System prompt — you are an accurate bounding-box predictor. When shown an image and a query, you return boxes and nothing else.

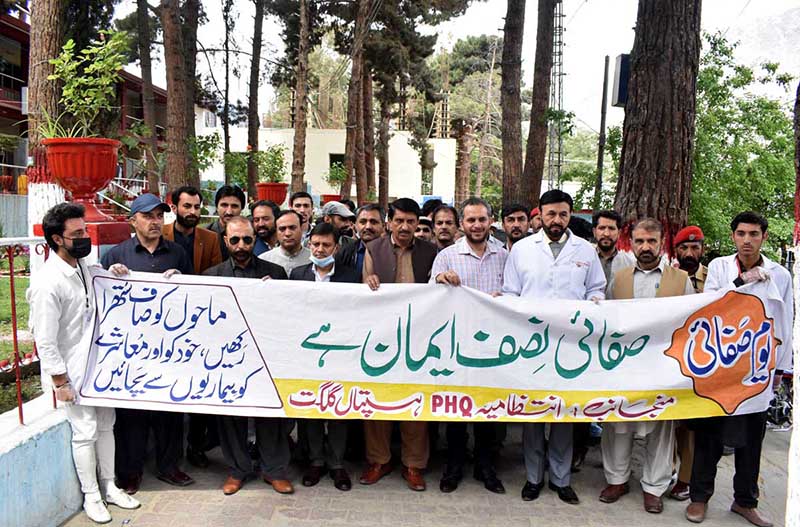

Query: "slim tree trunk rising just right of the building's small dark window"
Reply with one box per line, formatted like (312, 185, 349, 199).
(340, 0, 371, 199)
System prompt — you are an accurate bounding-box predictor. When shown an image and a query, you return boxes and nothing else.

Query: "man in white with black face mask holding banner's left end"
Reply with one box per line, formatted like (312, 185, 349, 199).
(29, 203, 139, 523)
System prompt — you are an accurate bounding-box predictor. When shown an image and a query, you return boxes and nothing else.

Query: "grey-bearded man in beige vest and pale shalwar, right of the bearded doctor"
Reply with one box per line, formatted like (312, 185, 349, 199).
(600, 218, 694, 514)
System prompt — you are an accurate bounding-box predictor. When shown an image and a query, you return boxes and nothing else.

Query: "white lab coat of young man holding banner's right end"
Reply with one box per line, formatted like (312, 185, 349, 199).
(703, 254, 794, 370)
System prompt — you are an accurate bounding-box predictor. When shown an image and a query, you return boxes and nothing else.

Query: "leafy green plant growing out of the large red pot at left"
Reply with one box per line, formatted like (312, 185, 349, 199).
(39, 31, 129, 138)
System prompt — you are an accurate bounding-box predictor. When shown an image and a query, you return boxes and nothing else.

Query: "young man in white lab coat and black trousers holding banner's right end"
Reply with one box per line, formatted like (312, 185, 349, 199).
(686, 212, 794, 527)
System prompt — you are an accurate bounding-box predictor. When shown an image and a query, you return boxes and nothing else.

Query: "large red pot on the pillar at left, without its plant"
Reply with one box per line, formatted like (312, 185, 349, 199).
(42, 137, 122, 222)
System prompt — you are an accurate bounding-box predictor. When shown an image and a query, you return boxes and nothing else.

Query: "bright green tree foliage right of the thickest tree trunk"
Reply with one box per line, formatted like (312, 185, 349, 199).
(689, 33, 795, 257)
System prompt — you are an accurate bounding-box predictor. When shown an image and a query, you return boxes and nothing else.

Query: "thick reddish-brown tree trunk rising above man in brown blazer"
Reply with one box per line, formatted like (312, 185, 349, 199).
(161, 0, 190, 187)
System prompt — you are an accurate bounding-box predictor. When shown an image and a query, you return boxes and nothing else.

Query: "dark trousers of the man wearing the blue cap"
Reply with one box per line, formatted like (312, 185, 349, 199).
(114, 408, 183, 479)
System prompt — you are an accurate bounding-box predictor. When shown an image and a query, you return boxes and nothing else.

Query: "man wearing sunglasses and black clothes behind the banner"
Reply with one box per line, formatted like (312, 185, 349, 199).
(203, 216, 294, 495)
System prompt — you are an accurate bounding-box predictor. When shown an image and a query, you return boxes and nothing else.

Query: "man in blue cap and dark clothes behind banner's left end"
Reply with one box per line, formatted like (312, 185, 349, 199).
(102, 194, 194, 494)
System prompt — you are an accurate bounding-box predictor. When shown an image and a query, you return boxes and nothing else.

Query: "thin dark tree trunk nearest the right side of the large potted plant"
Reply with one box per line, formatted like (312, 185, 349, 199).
(136, 0, 161, 194)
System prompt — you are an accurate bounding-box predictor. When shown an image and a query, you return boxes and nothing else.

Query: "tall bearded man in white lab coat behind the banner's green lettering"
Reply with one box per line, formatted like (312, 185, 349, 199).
(503, 190, 606, 504)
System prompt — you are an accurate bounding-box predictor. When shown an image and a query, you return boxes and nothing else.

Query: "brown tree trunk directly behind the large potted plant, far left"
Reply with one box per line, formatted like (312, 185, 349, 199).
(28, 0, 64, 156)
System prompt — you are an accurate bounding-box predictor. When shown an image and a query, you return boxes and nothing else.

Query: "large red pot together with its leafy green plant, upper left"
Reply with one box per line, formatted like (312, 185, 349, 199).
(39, 31, 128, 222)
